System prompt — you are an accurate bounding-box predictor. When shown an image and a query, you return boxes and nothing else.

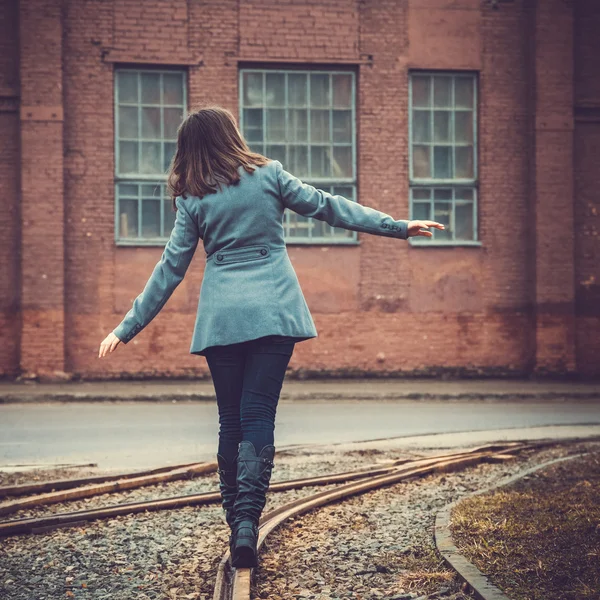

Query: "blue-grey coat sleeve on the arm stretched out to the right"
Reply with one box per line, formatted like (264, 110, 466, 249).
(274, 160, 408, 240)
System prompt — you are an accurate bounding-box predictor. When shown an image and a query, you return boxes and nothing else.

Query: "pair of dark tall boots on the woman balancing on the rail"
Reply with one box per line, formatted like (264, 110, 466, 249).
(231, 440, 275, 568)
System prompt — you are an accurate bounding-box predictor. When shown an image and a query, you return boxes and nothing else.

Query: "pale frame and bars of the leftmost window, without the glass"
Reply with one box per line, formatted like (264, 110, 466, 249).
(113, 69, 188, 247)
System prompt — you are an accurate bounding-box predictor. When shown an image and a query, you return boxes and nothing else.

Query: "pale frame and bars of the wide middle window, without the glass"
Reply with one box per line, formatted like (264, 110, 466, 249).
(238, 65, 360, 246)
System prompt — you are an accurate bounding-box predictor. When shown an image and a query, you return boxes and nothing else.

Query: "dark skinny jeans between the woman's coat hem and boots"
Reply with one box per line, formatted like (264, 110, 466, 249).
(206, 335, 296, 461)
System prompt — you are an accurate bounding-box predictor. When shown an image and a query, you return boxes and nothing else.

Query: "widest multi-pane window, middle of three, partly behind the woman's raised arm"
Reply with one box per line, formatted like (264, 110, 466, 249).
(240, 69, 357, 243)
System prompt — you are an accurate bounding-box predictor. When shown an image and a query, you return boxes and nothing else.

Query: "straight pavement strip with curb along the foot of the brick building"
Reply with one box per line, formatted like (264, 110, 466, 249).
(0, 377, 600, 404)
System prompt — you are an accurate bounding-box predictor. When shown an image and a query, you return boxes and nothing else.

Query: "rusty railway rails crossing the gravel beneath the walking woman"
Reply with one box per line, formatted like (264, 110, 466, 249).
(0, 438, 592, 600)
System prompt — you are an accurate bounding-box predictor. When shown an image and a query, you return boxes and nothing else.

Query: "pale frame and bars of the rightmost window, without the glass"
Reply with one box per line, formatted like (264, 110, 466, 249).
(408, 69, 482, 247)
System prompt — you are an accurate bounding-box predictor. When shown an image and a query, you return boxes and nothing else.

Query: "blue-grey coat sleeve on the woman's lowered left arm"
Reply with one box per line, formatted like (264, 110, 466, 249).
(113, 196, 201, 344)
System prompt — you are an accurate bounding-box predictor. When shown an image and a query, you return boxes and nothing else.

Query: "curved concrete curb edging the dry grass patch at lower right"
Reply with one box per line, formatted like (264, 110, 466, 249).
(434, 452, 589, 600)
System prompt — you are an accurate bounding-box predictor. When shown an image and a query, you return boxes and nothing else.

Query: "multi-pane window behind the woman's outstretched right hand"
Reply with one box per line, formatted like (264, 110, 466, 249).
(409, 72, 479, 245)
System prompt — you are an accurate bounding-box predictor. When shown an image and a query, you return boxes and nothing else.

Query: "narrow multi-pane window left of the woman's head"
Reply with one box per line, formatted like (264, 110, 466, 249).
(115, 68, 186, 245)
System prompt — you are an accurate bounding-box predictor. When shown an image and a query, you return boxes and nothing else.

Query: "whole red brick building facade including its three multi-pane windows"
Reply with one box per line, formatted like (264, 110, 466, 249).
(0, 0, 600, 378)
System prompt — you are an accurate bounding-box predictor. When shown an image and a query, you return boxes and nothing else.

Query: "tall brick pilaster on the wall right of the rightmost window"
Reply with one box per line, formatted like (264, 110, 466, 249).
(534, 0, 575, 372)
